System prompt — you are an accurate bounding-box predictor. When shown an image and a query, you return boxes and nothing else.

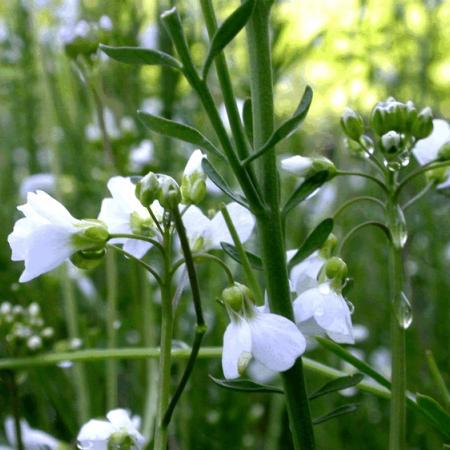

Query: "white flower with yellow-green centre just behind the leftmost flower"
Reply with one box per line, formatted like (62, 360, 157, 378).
(98, 177, 164, 258)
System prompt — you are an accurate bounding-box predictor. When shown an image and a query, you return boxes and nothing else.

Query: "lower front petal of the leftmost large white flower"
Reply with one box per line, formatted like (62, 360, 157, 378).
(19, 225, 74, 283)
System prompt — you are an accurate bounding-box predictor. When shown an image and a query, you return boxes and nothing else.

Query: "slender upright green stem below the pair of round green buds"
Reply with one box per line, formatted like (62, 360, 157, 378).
(154, 226, 173, 450)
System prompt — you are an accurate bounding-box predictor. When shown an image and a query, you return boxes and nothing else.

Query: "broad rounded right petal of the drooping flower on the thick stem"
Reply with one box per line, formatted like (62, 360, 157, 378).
(248, 312, 306, 372)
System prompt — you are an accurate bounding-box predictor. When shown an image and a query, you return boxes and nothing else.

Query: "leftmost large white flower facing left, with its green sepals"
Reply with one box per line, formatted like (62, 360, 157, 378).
(8, 191, 107, 282)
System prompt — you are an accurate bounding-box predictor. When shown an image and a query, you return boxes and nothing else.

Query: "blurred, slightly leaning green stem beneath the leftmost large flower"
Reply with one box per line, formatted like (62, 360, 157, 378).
(61, 266, 90, 424)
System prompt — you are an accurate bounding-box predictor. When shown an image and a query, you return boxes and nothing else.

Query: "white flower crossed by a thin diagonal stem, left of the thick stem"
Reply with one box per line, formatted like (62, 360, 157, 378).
(183, 202, 255, 252)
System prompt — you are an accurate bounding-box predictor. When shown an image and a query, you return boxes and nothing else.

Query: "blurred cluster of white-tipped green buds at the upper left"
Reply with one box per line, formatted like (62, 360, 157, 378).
(61, 16, 113, 58)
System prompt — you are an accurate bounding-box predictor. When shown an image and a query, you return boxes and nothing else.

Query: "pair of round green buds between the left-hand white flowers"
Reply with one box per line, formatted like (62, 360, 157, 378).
(136, 172, 181, 211)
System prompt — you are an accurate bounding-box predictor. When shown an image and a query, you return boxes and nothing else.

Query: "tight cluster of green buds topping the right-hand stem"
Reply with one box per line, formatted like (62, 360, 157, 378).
(341, 97, 433, 171)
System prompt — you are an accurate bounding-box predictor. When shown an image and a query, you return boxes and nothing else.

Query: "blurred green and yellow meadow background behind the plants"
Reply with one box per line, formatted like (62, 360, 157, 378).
(0, 0, 450, 450)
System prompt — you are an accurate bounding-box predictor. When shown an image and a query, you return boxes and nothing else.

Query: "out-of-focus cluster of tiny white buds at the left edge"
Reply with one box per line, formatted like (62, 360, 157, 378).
(0, 302, 54, 356)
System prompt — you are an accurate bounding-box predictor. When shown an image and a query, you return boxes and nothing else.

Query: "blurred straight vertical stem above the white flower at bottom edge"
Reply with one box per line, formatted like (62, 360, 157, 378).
(106, 252, 118, 411)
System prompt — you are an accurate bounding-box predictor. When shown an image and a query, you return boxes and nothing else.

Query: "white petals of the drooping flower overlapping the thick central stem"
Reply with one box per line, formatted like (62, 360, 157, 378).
(222, 305, 306, 379)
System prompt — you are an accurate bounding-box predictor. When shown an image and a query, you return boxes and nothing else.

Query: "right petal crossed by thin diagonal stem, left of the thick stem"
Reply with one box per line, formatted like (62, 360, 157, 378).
(210, 202, 255, 248)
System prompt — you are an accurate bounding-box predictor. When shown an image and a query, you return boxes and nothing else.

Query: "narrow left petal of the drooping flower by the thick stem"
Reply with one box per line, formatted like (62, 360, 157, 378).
(222, 320, 252, 380)
